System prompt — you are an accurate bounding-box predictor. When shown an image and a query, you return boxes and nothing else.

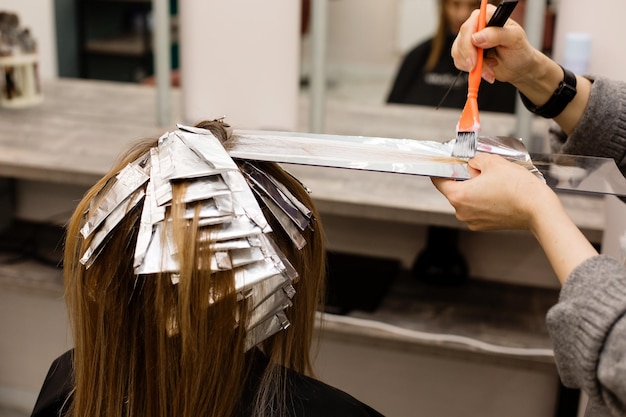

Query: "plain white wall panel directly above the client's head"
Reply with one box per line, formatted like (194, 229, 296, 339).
(179, 0, 300, 130)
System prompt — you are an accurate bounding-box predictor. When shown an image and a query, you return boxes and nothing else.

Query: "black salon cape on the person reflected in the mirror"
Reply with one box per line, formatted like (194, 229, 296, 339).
(387, 34, 517, 113)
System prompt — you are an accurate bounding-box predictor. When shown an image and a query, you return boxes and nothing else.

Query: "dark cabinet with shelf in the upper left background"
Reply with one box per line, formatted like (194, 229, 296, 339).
(77, 0, 178, 82)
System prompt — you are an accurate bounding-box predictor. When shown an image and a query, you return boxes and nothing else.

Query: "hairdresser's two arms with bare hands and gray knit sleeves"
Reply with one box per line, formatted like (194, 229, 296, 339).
(432, 7, 626, 417)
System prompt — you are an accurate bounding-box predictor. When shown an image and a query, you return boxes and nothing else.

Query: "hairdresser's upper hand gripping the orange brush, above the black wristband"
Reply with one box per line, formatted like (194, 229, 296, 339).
(452, 5, 549, 85)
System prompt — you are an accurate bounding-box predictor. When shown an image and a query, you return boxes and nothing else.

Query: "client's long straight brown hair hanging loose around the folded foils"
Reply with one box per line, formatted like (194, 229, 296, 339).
(64, 122, 325, 417)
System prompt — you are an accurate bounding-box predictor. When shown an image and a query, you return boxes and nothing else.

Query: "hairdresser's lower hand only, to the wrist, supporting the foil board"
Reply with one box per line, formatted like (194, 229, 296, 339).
(432, 153, 561, 230)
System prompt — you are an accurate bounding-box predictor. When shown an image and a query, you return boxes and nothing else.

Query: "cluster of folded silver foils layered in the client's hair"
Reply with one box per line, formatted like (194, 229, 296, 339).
(81, 126, 313, 348)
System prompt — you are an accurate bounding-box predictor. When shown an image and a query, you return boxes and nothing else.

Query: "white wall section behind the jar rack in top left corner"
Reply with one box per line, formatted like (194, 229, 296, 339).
(0, 0, 57, 79)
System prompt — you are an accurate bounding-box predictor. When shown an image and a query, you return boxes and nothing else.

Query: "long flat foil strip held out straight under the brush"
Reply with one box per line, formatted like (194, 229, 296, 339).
(224, 130, 528, 179)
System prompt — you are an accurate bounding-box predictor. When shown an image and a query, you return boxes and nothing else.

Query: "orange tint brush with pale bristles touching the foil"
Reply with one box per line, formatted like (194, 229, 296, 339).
(452, 0, 488, 159)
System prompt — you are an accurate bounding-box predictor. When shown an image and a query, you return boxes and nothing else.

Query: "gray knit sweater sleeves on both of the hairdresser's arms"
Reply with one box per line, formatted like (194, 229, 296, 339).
(547, 77, 626, 417)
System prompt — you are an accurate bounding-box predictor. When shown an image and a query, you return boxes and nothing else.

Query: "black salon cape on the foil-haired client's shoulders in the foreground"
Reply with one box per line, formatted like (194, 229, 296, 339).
(31, 351, 383, 417)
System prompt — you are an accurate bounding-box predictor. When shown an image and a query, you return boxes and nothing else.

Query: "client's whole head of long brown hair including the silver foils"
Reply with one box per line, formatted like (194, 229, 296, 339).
(64, 122, 325, 416)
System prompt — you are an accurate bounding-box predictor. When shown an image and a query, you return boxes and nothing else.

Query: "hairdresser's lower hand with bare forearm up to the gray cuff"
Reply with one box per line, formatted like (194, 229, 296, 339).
(432, 154, 598, 283)
